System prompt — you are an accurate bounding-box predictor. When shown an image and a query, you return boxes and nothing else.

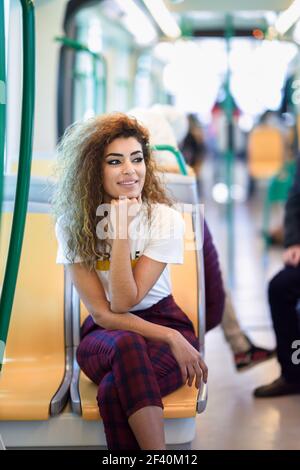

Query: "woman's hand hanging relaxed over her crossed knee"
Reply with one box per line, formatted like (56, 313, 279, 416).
(168, 330, 208, 388)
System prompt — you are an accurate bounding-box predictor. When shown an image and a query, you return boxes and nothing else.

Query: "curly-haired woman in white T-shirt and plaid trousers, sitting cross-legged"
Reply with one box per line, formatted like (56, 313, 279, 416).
(53, 113, 207, 450)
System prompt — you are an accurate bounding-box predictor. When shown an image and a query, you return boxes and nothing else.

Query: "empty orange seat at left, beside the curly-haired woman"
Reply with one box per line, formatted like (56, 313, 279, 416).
(0, 178, 72, 422)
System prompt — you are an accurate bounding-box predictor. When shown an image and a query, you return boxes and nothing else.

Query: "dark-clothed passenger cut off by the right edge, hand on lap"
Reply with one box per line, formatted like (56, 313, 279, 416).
(254, 158, 300, 398)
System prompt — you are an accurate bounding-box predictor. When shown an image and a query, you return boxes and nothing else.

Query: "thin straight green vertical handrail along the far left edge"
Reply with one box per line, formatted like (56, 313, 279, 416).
(0, 2, 6, 228)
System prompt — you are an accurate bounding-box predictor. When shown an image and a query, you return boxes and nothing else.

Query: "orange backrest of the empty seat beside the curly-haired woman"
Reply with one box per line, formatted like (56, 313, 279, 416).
(0, 202, 65, 364)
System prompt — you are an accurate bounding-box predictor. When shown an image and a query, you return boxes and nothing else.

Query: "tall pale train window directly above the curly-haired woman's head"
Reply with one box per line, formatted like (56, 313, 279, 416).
(58, 2, 144, 136)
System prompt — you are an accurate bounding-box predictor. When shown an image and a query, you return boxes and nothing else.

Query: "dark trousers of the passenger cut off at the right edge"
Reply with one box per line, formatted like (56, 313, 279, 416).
(269, 266, 300, 383)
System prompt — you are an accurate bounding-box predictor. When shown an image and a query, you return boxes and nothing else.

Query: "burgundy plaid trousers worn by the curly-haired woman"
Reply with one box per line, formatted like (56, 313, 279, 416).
(77, 295, 199, 450)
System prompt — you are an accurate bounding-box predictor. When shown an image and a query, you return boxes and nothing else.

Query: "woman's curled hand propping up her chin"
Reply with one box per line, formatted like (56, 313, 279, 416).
(111, 195, 142, 238)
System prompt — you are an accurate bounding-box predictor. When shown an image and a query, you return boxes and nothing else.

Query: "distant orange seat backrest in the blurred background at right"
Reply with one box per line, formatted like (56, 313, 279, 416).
(248, 125, 284, 179)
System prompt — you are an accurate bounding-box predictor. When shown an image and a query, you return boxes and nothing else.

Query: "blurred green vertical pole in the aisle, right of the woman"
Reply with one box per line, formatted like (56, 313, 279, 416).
(224, 14, 234, 287)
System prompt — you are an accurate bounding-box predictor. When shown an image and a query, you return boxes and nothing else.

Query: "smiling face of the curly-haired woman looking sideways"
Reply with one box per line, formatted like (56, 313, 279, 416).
(102, 137, 146, 202)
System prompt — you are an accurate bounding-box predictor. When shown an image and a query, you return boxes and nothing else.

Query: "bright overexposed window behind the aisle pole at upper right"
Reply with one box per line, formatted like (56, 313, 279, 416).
(164, 37, 297, 121)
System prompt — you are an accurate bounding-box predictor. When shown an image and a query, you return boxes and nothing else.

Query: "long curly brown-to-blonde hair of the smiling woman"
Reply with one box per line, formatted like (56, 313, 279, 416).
(52, 113, 173, 269)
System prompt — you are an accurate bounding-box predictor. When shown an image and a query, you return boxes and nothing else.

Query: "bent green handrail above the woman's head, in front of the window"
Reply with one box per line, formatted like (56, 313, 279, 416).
(55, 36, 107, 111)
